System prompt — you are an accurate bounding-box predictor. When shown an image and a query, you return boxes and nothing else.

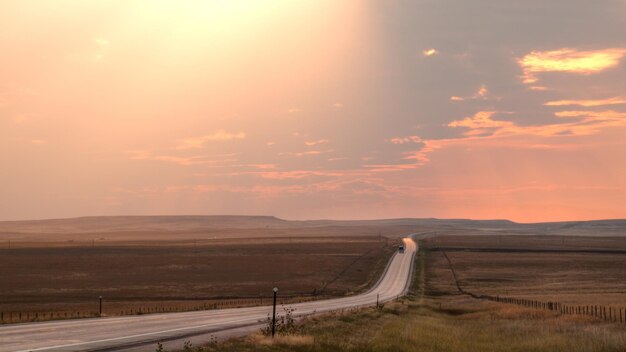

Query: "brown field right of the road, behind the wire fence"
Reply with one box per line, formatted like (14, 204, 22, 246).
(423, 235, 626, 306)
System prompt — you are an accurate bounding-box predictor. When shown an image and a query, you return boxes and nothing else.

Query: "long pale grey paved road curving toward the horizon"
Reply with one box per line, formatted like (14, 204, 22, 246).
(0, 238, 417, 352)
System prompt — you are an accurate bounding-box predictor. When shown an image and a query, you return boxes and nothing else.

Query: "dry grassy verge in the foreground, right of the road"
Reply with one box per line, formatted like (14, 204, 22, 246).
(172, 241, 626, 352)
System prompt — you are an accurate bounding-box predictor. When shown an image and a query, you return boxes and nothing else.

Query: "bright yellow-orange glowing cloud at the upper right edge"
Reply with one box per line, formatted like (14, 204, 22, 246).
(518, 48, 626, 83)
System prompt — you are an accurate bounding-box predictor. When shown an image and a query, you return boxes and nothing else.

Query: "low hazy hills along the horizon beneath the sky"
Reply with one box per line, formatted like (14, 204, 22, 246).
(0, 215, 626, 236)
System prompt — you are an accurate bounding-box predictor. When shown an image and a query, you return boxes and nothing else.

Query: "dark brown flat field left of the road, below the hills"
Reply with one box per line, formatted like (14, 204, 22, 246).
(0, 236, 395, 317)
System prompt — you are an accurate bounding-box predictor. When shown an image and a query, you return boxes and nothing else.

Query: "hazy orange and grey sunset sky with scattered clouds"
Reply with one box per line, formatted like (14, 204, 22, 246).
(0, 0, 626, 222)
